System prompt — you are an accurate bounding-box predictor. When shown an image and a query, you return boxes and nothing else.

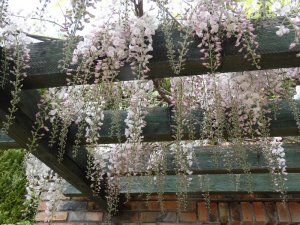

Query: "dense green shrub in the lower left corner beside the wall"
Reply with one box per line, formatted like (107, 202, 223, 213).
(0, 150, 34, 225)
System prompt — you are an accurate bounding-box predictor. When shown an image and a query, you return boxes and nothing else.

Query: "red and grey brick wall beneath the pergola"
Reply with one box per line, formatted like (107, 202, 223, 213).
(36, 195, 300, 225)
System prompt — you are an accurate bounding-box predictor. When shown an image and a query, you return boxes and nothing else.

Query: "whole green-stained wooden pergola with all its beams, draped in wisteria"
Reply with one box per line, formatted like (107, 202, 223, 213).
(0, 19, 300, 209)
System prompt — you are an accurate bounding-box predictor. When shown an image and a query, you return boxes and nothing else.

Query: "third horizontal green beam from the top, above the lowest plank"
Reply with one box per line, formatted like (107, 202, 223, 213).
(69, 144, 300, 176)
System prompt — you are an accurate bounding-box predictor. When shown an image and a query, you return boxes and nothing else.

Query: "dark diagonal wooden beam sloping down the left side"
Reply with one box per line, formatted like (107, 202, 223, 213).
(0, 89, 106, 207)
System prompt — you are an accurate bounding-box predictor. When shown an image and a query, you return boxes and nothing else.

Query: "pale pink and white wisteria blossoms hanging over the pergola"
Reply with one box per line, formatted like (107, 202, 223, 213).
(0, 0, 300, 221)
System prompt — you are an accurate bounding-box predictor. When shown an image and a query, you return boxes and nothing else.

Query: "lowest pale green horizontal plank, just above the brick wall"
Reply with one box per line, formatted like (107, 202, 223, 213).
(119, 173, 300, 194)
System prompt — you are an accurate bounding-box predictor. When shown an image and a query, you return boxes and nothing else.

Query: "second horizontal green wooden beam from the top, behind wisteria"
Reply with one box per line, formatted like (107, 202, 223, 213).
(68, 101, 300, 145)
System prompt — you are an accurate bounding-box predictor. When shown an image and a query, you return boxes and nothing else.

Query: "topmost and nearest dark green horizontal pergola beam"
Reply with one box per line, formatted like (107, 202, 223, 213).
(24, 19, 300, 89)
